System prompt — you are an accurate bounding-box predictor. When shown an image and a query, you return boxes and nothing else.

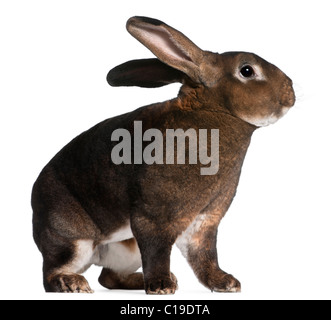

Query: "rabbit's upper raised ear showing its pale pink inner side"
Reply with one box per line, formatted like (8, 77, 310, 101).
(127, 17, 211, 83)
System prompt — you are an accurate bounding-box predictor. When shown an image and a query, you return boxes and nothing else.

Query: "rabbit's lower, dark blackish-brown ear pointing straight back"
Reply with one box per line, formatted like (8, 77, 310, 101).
(107, 59, 186, 88)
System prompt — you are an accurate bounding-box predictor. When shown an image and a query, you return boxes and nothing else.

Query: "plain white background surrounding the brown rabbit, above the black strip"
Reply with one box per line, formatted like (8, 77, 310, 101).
(0, 0, 331, 300)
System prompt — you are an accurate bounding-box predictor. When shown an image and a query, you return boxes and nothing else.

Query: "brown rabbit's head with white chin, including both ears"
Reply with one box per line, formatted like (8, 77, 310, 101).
(107, 17, 295, 127)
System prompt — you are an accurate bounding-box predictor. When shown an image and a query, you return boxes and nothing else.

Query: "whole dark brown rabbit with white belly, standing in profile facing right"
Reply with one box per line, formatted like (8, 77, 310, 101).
(31, 17, 295, 294)
